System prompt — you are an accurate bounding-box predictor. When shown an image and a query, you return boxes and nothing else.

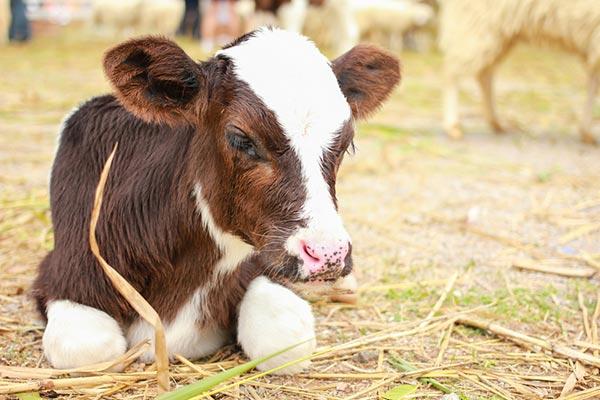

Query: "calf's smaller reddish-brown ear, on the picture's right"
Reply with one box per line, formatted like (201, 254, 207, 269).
(331, 44, 400, 119)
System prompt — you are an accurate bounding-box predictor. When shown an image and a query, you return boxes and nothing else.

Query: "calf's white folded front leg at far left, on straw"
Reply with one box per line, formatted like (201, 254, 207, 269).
(42, 300, 127, 369)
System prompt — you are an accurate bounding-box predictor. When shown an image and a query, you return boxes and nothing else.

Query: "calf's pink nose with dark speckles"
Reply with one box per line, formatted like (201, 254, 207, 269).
(300, 240, 350, 274)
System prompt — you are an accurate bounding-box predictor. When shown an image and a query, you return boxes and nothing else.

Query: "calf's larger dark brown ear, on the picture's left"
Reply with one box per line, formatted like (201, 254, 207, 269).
(104, 37, 203, 125)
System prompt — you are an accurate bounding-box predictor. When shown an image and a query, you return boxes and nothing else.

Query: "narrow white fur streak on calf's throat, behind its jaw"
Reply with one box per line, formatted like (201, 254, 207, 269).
(194, 184, 254, 274)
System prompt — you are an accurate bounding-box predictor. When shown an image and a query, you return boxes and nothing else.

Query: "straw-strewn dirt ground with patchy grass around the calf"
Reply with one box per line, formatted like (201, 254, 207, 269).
(0, 32, 600, 399)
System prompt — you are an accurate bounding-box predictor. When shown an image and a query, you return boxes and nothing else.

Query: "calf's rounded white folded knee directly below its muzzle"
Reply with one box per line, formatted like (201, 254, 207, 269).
(238, 277, 316, 374)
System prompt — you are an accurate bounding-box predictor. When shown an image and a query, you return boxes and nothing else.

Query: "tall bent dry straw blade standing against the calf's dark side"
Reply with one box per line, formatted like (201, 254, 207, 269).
(90, 143, 169, 391)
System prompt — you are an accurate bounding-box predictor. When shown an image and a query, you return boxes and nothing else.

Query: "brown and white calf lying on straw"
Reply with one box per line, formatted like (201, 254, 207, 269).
(34, 29, 399, 372)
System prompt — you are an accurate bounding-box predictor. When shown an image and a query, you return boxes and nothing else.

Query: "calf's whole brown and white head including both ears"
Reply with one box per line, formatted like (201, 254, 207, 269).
(104, 29, 399, 280)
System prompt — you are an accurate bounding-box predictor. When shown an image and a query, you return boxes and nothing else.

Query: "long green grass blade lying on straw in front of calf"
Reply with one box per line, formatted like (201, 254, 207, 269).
(158, 338, 313, 400)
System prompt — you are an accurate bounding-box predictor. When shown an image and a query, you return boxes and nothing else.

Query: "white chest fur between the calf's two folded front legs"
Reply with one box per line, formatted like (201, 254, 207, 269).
(127, 288, 227, 363)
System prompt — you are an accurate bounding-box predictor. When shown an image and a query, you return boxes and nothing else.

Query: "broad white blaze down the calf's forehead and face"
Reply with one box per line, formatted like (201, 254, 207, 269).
(218, 28, 351, 260)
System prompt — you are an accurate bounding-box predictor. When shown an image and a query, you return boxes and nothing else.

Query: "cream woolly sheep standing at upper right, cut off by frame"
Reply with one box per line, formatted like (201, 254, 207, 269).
(439, 0, 600, 143)
